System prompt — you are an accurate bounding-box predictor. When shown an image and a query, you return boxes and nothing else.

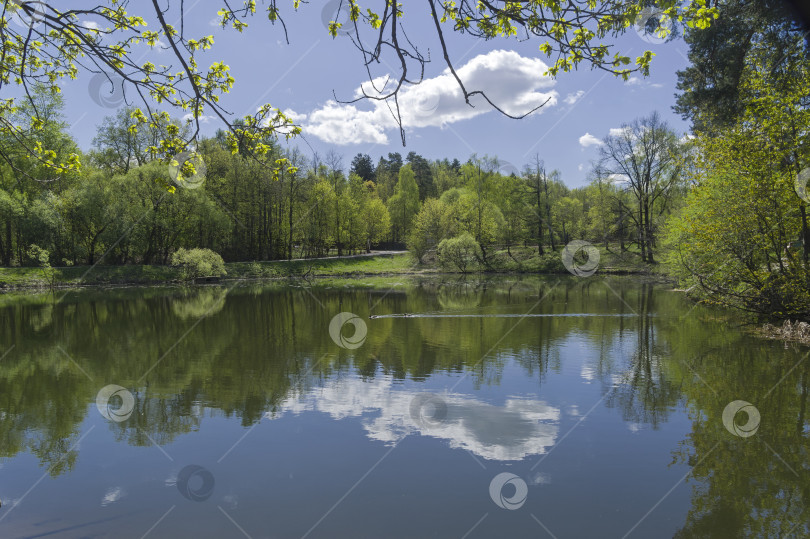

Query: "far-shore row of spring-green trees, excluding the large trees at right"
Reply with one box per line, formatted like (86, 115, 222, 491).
(0, 87, 682, 274)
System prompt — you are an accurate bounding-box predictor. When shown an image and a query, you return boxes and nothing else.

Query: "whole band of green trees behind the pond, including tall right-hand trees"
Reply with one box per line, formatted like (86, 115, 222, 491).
(0, 2, 810, 318)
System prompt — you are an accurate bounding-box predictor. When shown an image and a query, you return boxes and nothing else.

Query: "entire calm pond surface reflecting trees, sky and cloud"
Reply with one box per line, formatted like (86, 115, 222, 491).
(0, 276, 810, 538)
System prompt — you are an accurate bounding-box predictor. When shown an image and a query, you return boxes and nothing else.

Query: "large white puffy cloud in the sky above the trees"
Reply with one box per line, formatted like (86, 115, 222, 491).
(288, 50, 558, 144)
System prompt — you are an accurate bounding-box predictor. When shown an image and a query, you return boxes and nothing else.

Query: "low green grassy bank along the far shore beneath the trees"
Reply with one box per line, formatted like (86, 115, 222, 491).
(0, 247, 666, 290)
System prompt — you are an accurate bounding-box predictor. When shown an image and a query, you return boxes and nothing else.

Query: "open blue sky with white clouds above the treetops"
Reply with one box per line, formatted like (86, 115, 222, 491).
(55, 0, 688, 187)
